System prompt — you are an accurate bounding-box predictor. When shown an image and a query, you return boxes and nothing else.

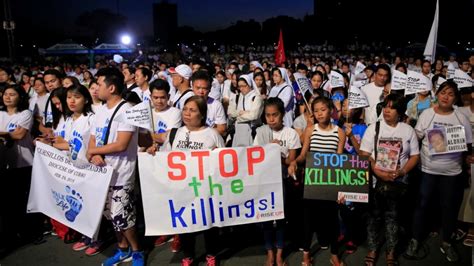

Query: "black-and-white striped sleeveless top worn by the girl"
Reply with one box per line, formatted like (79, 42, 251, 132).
(309, 124, 339, 153)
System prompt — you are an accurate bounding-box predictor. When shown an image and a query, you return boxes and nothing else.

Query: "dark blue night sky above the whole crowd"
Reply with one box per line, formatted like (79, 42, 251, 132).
(0, 0, 474, 53)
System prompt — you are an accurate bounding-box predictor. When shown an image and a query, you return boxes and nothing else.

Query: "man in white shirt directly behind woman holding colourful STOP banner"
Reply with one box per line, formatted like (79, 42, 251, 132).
(191, 70, 227, 135)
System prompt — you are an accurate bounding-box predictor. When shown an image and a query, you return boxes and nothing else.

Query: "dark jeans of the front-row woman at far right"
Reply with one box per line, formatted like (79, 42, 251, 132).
(413, 172, 463, 242)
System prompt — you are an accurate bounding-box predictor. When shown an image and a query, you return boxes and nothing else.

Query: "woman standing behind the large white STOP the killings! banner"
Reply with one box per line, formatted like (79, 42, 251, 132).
(158, 96, 224, 266)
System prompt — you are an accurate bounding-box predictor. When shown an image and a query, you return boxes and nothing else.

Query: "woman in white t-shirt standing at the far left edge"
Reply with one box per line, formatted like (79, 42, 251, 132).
(0, 85, 33, 245)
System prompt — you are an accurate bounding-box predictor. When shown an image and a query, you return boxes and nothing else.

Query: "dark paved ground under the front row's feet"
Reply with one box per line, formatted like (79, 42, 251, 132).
(0, 229, 474, 266)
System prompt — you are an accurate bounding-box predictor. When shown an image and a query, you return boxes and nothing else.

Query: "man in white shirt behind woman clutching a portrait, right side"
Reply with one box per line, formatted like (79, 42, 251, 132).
(361, 64, 392, 125)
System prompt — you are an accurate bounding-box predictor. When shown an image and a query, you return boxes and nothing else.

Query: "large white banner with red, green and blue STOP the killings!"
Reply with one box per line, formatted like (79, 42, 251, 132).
(138, 144, 284, 235)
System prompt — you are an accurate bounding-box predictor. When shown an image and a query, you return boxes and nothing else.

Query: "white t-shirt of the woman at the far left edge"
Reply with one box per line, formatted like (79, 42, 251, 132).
(0, 110, 34, 168)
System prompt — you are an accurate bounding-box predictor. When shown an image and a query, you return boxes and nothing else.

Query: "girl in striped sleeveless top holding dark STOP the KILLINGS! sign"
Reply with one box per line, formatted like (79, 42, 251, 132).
(288, 97, 346, 266)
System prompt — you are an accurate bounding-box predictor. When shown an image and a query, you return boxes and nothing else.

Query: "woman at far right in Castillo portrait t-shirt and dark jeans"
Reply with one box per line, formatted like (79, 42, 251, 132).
(405, 81, 472, 262)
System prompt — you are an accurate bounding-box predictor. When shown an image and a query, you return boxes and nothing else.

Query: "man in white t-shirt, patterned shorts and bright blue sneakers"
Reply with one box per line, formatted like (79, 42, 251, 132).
(87, 68, 145, 266)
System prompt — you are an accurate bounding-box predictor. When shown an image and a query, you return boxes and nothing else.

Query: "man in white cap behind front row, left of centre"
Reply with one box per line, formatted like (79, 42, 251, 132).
(169, 64, 194, 110)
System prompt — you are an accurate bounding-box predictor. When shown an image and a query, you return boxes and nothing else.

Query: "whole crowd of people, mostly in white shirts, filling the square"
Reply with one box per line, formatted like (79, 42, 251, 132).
(0, 52, 474, 265)
